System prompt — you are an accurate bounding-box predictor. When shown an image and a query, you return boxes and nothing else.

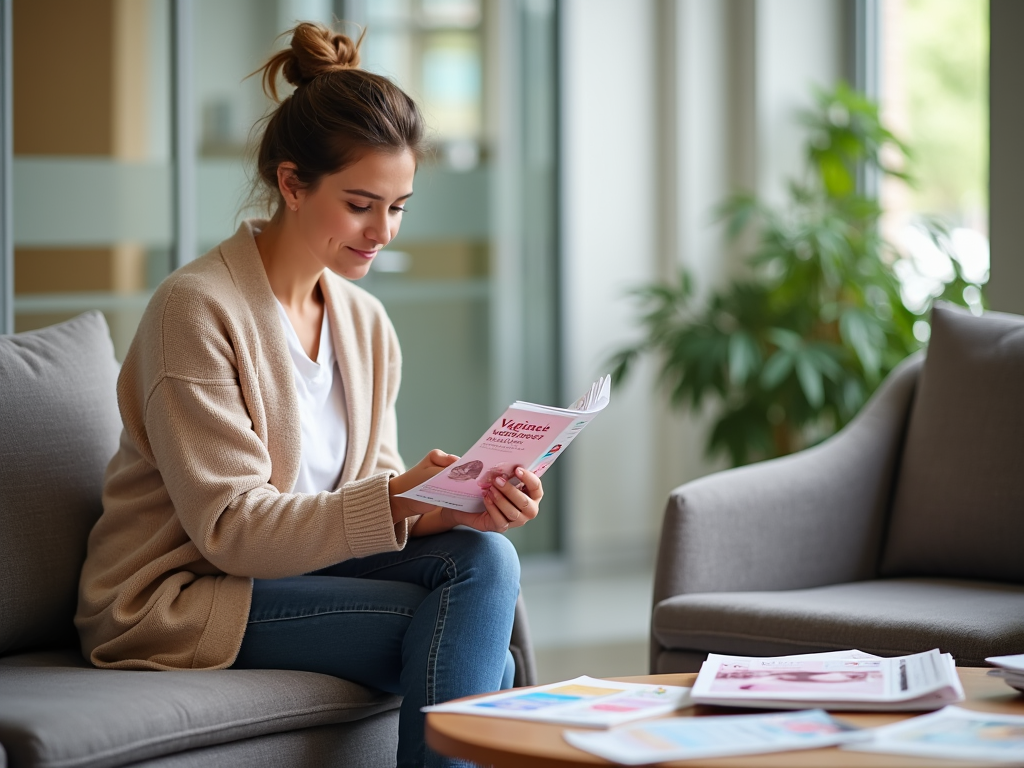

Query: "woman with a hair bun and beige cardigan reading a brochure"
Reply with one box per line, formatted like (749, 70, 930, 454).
(76, 24, 543, 765)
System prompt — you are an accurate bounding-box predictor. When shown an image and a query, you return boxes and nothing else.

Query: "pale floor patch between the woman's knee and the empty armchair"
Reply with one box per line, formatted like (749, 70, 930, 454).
(522, 563, 653, 683)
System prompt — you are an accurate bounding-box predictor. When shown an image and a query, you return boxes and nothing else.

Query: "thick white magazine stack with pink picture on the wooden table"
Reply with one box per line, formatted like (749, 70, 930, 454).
(693, 649, 964, 712)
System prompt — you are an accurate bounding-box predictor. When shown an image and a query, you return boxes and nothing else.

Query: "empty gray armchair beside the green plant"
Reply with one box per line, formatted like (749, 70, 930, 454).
(650, 305, 1024, 672)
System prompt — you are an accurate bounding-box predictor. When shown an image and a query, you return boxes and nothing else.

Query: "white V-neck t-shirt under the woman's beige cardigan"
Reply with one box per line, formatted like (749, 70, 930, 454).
(278, 301, 348, 494)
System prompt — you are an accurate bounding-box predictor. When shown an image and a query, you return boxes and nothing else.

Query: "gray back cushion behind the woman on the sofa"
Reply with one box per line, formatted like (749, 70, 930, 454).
(0, 312, 121, 654)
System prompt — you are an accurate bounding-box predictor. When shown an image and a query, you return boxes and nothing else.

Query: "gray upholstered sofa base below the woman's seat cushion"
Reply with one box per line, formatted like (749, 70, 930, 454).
(117, 710, 398, 768)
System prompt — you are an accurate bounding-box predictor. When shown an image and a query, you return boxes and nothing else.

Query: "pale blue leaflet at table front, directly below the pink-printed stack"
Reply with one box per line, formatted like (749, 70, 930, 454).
(564, 710, 863, 765)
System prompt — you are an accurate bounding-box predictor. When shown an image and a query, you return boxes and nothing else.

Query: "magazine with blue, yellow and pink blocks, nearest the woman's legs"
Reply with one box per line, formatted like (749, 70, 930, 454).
(423, 676, 690, 728)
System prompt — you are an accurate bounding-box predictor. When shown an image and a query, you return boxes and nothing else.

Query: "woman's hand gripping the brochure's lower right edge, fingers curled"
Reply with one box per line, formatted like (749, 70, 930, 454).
(407, 467, 544, 536)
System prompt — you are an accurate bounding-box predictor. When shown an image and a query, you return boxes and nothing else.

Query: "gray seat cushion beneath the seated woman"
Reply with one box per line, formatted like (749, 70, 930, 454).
(0, 651, 401, 768)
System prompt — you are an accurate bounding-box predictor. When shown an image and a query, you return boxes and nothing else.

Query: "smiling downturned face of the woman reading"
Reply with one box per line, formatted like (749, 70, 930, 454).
(295, 150, 416, 280)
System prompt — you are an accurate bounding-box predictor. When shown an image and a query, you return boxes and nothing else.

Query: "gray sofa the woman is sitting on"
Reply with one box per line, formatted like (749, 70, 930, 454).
(0, 312, 536, 768)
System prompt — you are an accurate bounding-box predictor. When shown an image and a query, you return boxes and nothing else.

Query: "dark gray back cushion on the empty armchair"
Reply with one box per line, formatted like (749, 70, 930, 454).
(882, 305, 1024, 585)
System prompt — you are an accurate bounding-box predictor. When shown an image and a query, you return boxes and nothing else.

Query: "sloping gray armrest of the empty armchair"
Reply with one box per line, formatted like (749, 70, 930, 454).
(654, 353, 924, 606)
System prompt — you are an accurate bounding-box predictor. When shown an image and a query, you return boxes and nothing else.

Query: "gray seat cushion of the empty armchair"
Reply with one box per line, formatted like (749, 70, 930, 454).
(652, 579, 1024, 666)
